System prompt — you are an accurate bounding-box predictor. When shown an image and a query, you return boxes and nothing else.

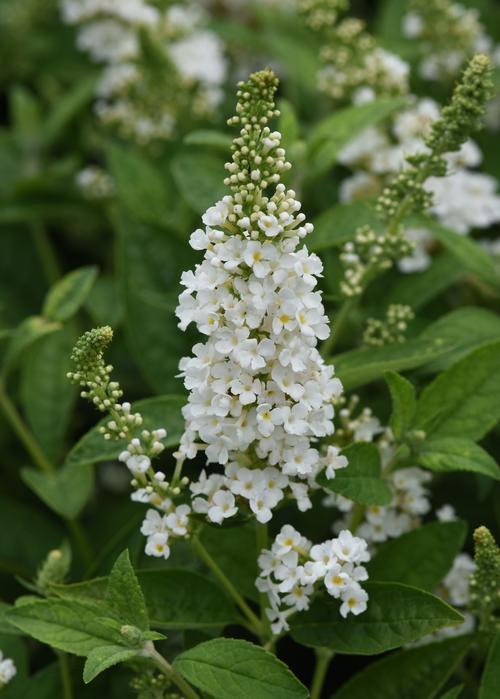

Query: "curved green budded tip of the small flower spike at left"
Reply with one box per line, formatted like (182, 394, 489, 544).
(67, 325, 142, 439)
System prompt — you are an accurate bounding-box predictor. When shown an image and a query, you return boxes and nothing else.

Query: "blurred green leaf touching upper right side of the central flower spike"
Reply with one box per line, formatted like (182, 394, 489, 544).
(307, 201, 380, 252)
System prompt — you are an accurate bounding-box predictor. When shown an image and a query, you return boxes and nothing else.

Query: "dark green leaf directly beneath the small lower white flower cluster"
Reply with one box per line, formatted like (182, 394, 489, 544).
(292, 582, 463, 655)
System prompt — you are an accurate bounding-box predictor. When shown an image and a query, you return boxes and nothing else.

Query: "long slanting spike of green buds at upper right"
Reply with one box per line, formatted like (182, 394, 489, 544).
(341, 54, 492, 297)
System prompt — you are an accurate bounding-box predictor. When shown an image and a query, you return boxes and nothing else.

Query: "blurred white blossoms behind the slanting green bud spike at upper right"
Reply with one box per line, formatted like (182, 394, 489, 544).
(339, 98, 500, 272)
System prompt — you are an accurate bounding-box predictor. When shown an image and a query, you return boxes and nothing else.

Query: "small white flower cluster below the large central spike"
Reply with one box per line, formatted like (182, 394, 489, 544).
(256, 524, 370, 635)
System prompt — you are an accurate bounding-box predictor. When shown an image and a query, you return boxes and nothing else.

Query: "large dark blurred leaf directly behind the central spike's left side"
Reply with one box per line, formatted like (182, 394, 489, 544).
(115, 212, 194, 393)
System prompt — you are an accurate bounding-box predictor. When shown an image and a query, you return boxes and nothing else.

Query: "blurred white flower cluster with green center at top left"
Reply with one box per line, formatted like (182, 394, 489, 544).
(61, 0, 227, 143)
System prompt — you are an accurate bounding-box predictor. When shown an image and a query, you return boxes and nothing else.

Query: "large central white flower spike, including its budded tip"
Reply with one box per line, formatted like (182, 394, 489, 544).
(176, 70, 342, 522)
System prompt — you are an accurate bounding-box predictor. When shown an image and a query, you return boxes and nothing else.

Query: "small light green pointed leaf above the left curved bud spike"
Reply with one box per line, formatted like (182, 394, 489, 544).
(43, 267, 97, 323)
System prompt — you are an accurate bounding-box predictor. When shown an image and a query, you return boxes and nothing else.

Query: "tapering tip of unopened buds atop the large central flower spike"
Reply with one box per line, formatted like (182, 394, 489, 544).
(224, 68, 291, 208)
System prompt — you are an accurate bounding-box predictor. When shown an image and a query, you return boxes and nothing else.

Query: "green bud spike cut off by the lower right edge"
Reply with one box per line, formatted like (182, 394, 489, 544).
(470, 527, 500, 633)
